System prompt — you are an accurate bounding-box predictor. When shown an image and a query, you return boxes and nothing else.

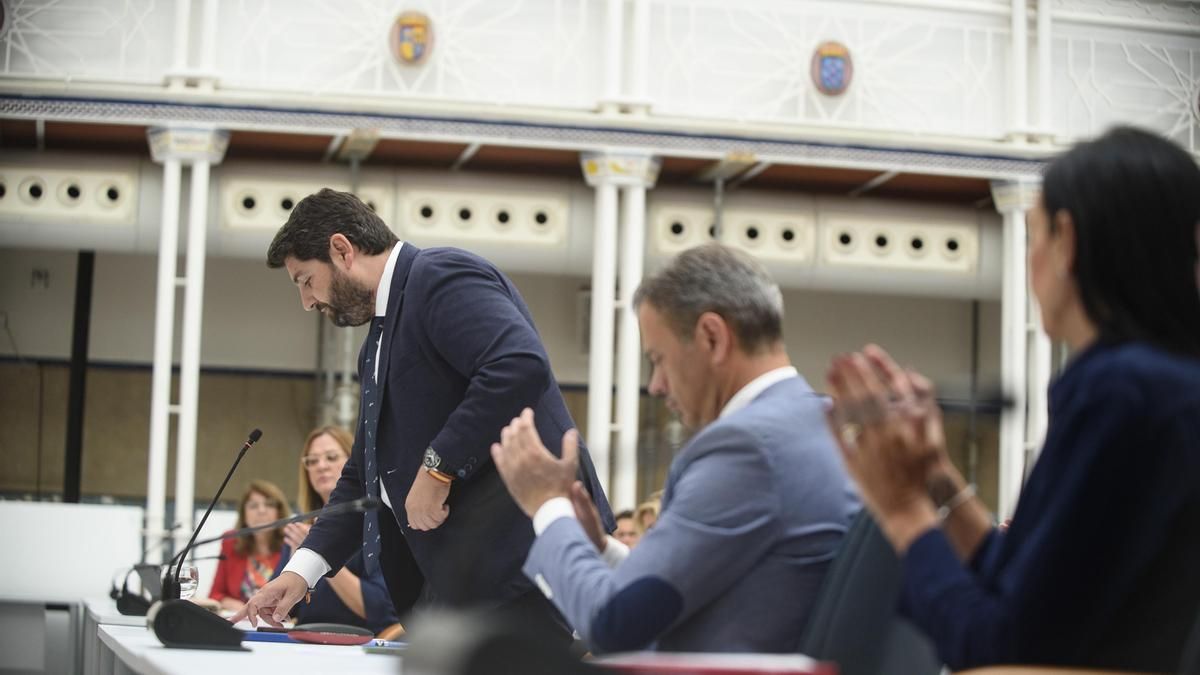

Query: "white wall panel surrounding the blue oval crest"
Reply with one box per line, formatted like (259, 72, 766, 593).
(649, 0, 1008, 138)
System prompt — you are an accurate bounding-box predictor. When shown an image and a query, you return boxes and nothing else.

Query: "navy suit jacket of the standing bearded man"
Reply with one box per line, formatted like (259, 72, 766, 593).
(305, 244, 614, 613)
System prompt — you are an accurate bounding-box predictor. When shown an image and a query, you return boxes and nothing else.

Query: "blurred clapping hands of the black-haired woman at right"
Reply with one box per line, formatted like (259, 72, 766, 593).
(827, 345, 949, 552)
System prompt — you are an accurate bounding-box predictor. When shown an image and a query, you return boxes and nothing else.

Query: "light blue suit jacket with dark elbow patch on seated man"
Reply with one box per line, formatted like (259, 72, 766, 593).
(524, 377, 859, 652)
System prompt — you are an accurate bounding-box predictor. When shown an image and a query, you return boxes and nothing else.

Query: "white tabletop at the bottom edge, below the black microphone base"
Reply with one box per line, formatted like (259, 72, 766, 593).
(98, 625, 402, 675)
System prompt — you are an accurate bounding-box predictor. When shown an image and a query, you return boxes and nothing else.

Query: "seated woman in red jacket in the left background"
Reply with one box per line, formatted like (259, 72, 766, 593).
(209, 480, 292, 611)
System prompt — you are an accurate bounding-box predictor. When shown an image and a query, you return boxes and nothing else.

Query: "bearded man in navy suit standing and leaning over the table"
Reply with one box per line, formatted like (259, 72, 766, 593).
(235, 189, 614, 638)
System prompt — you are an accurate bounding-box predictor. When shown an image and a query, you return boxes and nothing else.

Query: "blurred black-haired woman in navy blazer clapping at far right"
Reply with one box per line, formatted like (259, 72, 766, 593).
(828, 127, 1200, 671)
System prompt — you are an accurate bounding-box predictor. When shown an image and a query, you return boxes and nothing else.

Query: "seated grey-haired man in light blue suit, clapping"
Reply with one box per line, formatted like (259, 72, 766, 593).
(492, 244, 859, 652)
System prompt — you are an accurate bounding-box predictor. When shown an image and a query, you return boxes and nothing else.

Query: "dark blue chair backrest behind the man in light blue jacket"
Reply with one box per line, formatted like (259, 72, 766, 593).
(800, 510, 942, 675)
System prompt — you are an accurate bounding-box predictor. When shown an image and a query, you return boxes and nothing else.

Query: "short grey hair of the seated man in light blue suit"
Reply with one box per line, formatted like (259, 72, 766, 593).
(634, 244, 784, 354)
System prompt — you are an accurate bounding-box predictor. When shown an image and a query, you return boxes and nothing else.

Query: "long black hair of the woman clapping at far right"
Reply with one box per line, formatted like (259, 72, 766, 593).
(1042, 126, 1200, 357)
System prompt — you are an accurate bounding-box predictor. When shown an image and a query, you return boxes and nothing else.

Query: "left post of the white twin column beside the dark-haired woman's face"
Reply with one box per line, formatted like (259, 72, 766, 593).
(991, 181, 1038, 518)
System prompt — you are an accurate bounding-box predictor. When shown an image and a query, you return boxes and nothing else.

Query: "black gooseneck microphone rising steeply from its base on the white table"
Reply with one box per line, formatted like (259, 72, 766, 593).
(146, 429, 263, 650)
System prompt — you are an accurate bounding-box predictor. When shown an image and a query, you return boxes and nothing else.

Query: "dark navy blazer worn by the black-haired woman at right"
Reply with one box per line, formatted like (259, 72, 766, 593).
(902, 342, 1200, 673)
